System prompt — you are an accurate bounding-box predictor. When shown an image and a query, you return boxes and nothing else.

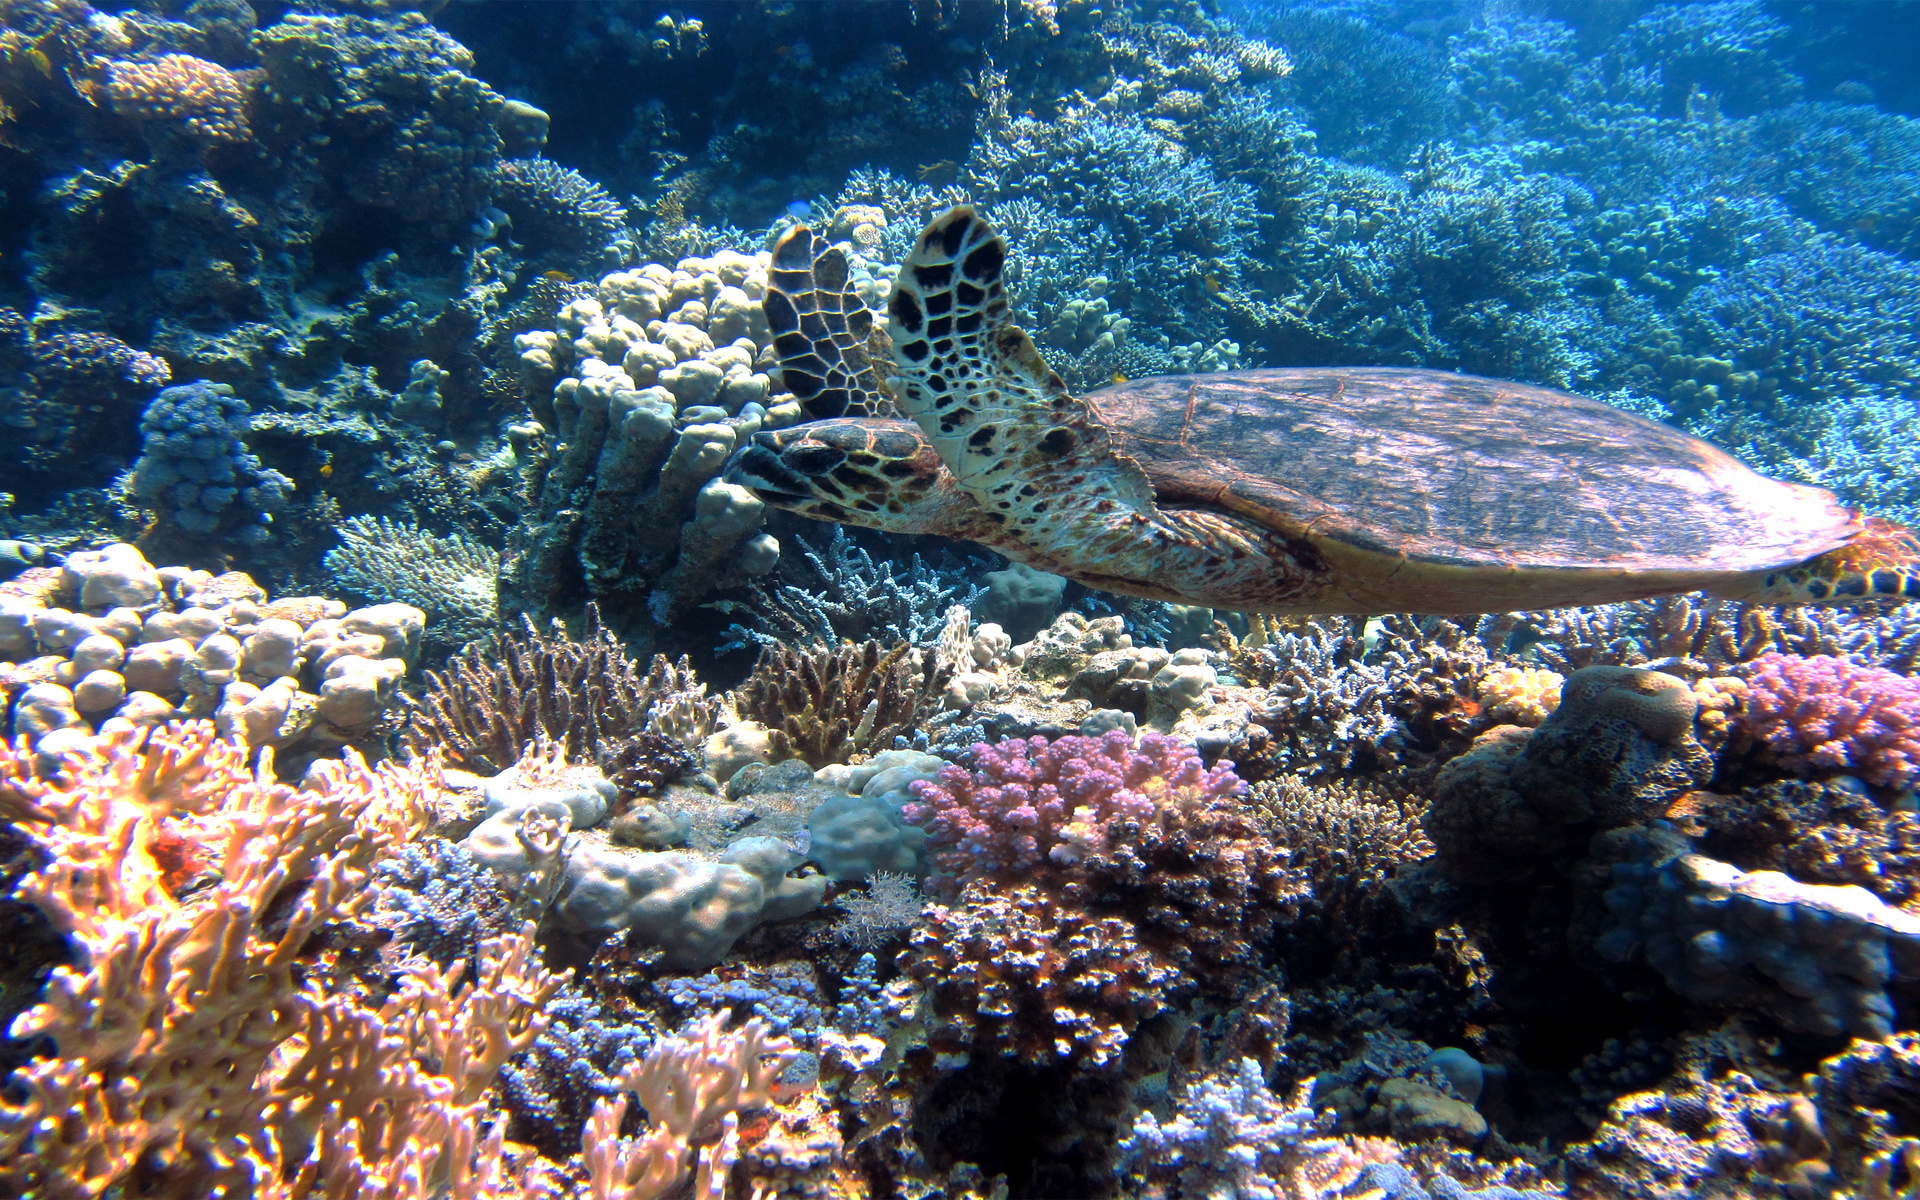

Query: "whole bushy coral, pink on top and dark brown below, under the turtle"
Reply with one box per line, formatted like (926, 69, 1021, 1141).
(906, 730, 1302, 1066)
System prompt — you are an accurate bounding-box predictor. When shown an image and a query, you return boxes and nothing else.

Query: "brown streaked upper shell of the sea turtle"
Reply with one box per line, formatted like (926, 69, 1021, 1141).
(1087, 367, 1862, 576)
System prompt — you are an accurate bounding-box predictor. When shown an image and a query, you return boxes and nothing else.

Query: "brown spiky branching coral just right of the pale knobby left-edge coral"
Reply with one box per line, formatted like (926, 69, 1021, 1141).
(407, 607, 714, 774)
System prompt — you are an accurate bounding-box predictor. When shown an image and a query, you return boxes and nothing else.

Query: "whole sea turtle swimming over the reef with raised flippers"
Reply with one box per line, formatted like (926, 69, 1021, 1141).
(728, 205, 1920, 614)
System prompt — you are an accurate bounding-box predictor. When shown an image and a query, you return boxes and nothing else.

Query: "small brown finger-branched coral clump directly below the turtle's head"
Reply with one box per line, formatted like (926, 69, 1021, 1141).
(733, 641, 952, 770)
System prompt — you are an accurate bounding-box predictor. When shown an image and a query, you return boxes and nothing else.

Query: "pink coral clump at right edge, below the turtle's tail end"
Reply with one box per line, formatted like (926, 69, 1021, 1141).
(1741, 655, 1920, 787)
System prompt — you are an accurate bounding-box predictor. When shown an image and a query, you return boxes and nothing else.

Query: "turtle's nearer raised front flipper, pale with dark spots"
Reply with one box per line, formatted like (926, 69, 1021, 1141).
(887, 205, 1158, 559)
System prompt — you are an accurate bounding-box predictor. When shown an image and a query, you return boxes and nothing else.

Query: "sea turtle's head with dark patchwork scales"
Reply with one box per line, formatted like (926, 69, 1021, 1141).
(726, 417, 950, 534)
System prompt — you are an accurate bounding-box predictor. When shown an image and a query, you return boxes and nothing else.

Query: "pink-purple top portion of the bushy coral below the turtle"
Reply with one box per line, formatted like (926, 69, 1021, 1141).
(904, 730, 1246, 881)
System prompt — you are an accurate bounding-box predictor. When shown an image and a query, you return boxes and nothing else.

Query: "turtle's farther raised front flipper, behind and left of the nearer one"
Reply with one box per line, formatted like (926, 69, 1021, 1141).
(762, 225, 900, 420)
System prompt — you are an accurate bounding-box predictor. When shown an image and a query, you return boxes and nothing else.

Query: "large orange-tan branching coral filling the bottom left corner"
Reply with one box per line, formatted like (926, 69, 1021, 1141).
(0, 722, 559, 1194)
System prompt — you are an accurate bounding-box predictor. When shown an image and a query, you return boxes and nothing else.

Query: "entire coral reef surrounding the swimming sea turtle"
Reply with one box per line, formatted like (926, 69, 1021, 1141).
(0, 0, 1920, 1200)
